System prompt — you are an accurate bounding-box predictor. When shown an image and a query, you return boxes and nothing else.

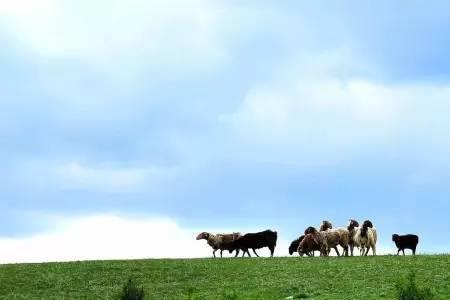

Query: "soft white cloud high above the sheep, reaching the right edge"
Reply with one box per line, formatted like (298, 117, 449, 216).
(220, 59, 450, 163)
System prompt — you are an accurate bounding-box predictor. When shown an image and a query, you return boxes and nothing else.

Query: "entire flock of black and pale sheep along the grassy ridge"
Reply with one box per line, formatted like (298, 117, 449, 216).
(197, 219, 419, 257)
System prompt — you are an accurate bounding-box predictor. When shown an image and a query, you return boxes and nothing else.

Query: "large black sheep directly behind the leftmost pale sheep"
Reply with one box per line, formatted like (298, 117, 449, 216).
(233, 230, 278, 257)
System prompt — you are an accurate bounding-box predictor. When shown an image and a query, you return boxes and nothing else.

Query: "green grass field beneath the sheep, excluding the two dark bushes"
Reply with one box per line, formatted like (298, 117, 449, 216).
(0, 255, 450, 300)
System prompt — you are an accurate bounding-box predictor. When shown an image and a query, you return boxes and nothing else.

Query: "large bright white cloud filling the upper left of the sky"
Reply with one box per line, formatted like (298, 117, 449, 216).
(0, 0, 282, 118)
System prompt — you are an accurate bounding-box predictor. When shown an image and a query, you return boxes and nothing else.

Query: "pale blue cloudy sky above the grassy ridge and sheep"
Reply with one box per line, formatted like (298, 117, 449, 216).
(0, 0, 450, 262)
